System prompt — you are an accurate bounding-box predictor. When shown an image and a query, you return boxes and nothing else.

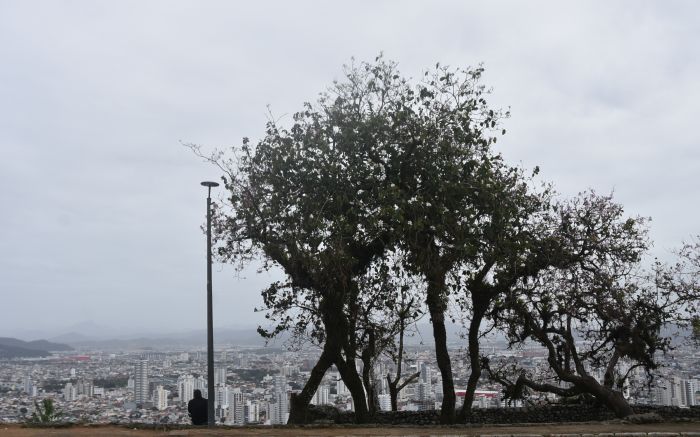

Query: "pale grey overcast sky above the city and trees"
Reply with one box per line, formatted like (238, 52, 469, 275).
(0, 0, 700, 336)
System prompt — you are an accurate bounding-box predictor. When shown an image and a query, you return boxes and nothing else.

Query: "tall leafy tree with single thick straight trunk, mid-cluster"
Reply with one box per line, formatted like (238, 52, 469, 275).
(386, 65, 521, 423)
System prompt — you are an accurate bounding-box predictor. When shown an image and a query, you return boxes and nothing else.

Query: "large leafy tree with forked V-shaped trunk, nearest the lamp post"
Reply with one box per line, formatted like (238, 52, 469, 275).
(197, 59, 424, 422)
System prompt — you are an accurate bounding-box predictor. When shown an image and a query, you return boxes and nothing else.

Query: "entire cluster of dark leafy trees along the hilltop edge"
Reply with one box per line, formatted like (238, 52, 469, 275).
(189, 56, 700, 423)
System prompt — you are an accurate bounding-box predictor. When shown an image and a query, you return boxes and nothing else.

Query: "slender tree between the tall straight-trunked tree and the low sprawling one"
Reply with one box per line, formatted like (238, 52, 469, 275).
(454, 163, 564, 422)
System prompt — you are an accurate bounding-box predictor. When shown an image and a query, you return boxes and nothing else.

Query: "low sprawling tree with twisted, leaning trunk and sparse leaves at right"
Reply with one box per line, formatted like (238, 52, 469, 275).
(486, 194, 678, 417)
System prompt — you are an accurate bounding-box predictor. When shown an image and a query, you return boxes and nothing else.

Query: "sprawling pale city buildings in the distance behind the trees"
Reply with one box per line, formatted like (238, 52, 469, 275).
(0, 338, 700, 425)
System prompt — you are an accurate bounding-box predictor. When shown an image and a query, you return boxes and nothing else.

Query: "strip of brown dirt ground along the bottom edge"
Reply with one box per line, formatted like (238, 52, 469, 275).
(0, 422, 700, 437)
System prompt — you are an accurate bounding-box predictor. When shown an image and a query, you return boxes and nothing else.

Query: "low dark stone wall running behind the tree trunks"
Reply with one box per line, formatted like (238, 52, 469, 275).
(310, 405, 700, 425)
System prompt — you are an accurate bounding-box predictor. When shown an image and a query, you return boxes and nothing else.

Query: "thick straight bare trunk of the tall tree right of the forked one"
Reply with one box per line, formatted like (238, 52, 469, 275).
(426, 274, 455, 424)
